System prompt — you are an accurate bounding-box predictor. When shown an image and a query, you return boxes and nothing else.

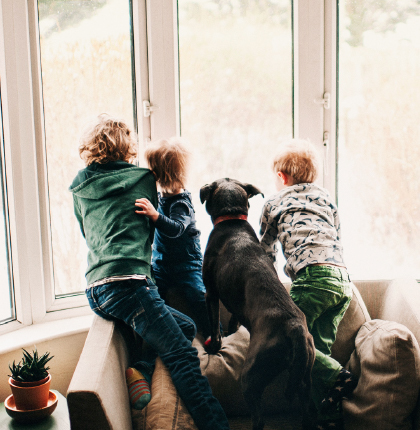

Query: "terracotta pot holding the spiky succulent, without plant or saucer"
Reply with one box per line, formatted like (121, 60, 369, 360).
(9, 374, 51, 411)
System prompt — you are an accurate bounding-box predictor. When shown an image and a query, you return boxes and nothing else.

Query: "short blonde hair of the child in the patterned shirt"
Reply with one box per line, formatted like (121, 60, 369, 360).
(272, 139, 320, 184)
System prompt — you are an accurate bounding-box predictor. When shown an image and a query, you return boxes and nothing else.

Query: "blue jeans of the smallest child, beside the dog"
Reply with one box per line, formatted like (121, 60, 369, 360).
(153, 268, 211, 339)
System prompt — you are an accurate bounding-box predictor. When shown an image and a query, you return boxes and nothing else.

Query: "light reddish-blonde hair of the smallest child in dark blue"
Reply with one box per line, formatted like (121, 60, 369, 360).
(144, 137, 190, 192)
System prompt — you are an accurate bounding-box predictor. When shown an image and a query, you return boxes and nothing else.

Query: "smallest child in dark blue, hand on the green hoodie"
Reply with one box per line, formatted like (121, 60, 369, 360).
(136, 138, 210, 338)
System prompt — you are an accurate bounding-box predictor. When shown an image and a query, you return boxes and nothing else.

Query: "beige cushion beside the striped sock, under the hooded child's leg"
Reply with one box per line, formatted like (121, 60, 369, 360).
(132, 357, 197, 430)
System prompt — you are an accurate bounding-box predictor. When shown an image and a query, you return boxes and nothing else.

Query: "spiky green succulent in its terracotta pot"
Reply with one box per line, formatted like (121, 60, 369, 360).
(9, 348, 53, 410)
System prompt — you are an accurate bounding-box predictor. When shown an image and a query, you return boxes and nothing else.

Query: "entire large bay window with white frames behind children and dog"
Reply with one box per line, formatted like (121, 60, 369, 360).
(0, 0, 420, 332)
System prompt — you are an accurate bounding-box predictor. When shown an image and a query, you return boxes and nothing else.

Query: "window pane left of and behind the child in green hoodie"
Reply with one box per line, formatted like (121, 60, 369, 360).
(38, 0, 134, 295)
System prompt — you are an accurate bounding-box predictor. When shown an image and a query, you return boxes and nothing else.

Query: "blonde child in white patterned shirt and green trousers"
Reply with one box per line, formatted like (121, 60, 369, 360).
(260, 139, 357, 430)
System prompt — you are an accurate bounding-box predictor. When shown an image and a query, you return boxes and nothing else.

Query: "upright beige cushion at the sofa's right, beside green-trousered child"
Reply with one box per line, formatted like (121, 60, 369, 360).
(343, 320, 420, 430)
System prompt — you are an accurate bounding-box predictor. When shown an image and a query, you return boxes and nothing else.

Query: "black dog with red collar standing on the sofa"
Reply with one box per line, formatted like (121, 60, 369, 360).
(200, 178, 315, 430)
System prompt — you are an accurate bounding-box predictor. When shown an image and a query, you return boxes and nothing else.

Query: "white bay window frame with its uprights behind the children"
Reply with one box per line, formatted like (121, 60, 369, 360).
(0, 0, 337, 333)
